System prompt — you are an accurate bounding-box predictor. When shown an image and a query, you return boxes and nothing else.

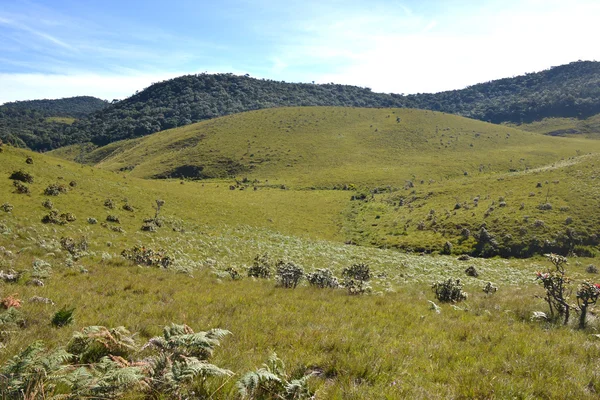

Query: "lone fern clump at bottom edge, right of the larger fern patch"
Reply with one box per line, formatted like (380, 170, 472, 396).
(237, 353, 314, 400)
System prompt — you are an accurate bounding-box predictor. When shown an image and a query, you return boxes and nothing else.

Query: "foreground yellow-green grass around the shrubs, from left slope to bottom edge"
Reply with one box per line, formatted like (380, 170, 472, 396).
(0, 144, 600, 399)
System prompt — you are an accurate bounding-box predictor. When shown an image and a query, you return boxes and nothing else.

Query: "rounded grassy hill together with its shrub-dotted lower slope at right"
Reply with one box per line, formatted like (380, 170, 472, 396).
(69, 107, 600, 257)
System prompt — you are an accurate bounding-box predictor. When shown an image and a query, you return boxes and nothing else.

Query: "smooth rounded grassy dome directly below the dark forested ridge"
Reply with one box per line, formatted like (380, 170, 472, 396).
(85, 107, 600, 187)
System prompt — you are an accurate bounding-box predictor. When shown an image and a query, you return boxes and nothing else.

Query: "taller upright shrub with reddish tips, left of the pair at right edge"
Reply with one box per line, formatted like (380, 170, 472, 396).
(536, 254, 571, 325)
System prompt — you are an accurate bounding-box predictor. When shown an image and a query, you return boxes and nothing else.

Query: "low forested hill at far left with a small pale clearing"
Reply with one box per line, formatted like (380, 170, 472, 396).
(0, 96, 108, 150)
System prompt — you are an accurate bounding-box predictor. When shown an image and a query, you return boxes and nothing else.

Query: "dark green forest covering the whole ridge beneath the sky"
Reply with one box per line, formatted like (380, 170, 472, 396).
(0, 61, 600, 150)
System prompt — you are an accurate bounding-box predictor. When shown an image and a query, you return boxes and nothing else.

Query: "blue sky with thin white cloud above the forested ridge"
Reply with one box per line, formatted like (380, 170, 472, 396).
(0, 0, 600, 104)
